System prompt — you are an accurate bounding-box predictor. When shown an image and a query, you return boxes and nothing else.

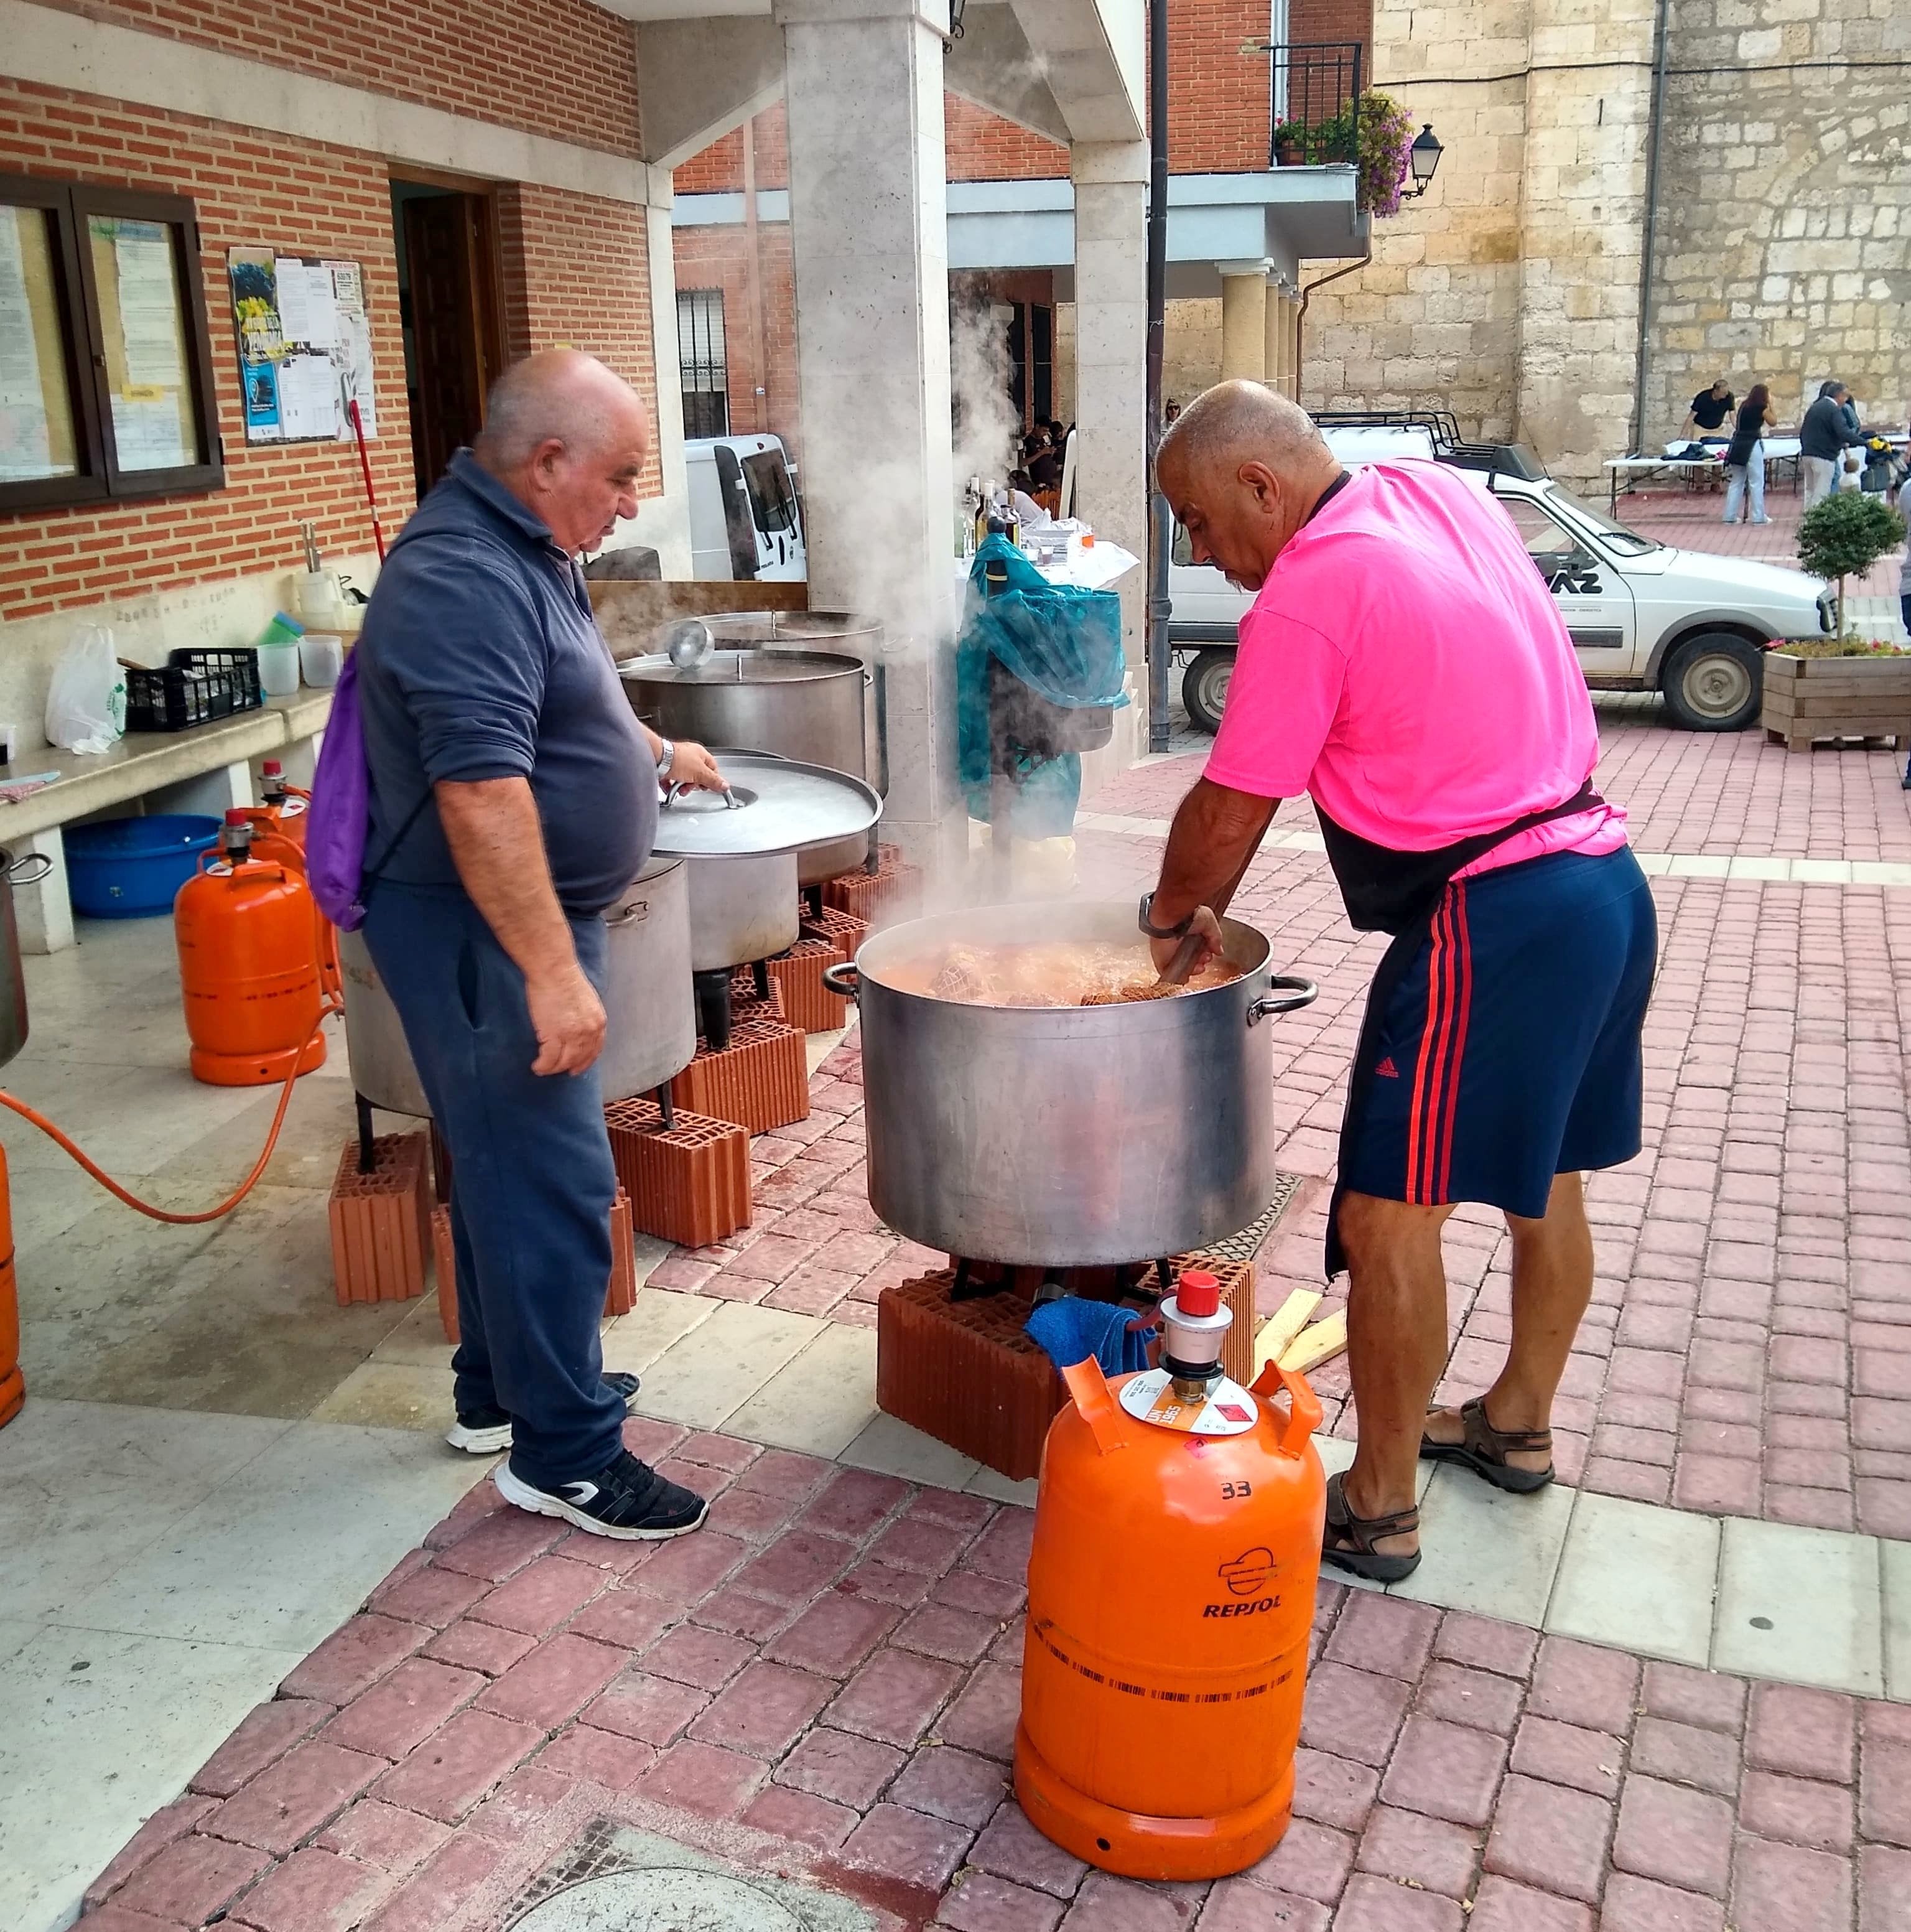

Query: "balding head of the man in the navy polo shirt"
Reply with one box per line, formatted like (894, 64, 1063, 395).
(472, 350, 649, 553)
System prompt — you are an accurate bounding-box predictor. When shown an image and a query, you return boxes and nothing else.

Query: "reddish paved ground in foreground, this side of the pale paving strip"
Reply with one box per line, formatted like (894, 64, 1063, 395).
(85, 1422, 1911, 1932)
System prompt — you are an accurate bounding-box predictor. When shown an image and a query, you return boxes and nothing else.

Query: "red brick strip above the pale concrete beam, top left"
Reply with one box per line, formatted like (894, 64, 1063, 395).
(42, 0, 638, 154)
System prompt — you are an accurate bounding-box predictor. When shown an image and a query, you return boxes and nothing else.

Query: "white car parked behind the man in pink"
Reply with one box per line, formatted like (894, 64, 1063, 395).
(1167, 416, 1838, 732)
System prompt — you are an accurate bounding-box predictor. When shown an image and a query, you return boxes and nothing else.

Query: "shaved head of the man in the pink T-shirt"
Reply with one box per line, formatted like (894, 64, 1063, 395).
(1155, 383, 1341, 589)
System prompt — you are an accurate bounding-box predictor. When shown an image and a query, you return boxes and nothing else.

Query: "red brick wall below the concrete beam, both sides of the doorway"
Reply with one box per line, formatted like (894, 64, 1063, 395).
(0, 79, 659, 620)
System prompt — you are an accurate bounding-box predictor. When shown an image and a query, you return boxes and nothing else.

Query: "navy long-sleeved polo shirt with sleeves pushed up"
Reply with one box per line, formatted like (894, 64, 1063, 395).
(351, 450, 657, 914)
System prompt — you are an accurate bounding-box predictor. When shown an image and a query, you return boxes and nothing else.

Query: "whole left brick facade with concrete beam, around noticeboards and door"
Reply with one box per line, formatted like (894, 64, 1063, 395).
(0, 0, 674, 745)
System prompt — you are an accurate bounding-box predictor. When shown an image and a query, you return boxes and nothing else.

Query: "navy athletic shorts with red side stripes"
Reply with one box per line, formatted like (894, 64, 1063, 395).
(1339, 848, 1658, 1219)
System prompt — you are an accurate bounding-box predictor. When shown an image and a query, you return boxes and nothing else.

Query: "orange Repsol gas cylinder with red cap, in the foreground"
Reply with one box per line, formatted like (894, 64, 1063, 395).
(1015, 1271, 1327, 1880)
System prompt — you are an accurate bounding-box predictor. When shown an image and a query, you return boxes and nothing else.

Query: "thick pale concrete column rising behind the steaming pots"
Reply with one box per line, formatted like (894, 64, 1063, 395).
(775, 0, 968, 866)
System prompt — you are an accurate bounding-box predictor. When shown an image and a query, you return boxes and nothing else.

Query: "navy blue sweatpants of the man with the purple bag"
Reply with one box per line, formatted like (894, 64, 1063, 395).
(363, 883, 624, 1490)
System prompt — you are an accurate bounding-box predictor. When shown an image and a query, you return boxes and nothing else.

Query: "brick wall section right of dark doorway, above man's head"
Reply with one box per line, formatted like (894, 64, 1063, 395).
(498, 182, 663, 497)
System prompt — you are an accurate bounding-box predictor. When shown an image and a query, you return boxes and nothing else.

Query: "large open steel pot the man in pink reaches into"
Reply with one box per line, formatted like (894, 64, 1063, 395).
(833, 902, 1316, 1266)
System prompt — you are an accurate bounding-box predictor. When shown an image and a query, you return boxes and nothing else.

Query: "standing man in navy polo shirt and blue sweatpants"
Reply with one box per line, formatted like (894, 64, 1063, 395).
(356, 350, 723, 1540)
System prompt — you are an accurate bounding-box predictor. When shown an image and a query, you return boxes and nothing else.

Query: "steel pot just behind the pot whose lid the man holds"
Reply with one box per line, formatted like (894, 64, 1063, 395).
(618, 645, 873, 885)
